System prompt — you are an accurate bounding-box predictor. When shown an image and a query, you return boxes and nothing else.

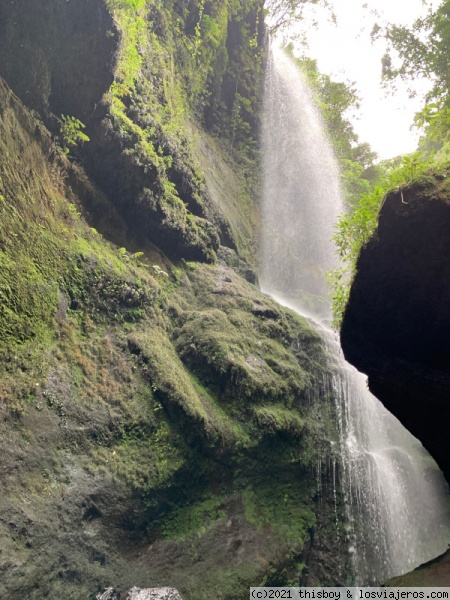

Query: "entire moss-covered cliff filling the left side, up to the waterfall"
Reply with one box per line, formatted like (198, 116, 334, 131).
(0, 0, 347, 600)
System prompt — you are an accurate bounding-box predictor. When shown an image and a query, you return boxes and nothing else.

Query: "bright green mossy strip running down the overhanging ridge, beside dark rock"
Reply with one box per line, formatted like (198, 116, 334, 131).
(100, 2, 223, 261)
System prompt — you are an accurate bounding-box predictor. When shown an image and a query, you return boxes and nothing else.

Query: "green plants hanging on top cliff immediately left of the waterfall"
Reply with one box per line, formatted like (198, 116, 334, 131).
(185, 0, 263, 160)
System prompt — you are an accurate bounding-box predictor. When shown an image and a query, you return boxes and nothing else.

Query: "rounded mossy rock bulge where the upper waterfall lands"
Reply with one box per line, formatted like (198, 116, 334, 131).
(175, 266, 326, 407)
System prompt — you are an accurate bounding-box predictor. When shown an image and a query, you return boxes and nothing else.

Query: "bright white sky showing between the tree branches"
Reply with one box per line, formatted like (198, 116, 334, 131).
(290, 0, 434, 159)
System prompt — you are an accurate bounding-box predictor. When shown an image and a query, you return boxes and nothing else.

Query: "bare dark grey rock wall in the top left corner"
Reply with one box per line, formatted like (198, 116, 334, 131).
(0, 0, 118, 123)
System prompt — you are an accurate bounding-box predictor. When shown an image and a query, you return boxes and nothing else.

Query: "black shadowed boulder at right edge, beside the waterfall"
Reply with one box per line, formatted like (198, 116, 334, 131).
(341, 178, 450, 481)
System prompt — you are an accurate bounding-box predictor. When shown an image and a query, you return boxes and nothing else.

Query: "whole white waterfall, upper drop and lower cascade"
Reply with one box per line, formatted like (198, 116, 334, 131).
(260, 47, 450, 585)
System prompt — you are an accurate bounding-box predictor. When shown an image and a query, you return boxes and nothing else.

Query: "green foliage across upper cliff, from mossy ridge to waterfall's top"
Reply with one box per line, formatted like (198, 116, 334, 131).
(98, 0, 262, 261)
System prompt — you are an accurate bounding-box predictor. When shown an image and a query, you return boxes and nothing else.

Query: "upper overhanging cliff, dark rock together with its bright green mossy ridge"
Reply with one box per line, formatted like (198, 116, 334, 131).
(0, 0, 264, 262)
